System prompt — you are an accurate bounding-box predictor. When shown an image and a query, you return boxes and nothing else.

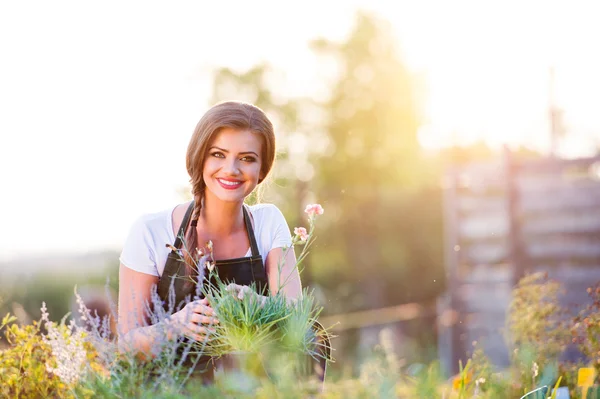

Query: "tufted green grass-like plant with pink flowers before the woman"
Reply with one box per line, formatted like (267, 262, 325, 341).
(172, 204, 333, 381)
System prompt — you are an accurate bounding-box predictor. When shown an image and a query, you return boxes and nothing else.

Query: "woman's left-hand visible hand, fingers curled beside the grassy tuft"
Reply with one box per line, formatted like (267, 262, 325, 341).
(167, 298, 219, 342)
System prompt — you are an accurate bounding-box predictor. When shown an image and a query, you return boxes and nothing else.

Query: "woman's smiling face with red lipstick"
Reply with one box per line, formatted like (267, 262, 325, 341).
(202, 128, 262, 202)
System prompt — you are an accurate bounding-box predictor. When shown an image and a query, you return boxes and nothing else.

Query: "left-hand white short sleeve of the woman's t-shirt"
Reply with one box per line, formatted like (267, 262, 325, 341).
(119, 217, 159, 276)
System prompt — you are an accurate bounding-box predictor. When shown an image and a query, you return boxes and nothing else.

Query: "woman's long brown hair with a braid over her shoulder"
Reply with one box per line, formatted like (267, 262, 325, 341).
(185, 101, 275, 273)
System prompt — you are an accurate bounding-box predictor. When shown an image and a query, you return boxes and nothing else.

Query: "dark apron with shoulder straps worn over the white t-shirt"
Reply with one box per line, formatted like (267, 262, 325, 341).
(158, 201, 269, 382)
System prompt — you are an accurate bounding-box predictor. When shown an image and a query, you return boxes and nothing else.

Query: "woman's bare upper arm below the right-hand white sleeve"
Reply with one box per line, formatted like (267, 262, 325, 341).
(265, 247, 302, 300)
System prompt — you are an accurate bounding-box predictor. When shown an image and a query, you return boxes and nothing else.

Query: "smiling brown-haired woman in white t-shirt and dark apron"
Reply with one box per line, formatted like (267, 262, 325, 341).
(118, 102, 302, 368)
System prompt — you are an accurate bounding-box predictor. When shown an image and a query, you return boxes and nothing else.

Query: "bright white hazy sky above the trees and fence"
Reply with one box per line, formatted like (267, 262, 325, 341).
(0, 0, 600, 261)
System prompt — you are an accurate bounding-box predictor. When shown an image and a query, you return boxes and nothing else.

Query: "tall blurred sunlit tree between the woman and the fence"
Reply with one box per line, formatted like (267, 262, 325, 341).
(312, 13, 444, 310)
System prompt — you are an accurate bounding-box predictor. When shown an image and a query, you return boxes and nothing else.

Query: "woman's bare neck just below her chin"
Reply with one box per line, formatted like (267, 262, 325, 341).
(198, 196, 244, 236)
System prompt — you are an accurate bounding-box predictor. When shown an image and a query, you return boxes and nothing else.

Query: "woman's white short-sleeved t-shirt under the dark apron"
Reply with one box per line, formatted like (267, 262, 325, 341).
(119, 204, 292, 276)
